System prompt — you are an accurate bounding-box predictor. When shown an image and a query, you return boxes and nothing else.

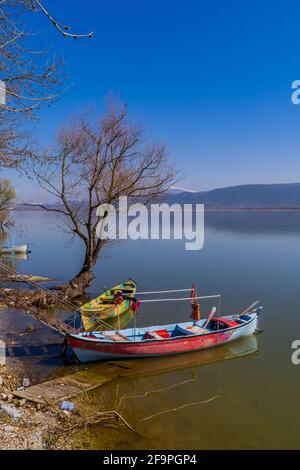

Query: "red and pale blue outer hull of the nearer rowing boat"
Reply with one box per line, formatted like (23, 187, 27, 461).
(68, 314, 258, 362)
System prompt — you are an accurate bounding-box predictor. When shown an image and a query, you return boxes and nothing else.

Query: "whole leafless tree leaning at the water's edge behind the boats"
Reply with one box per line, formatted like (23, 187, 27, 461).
(26, 104, 176, 294)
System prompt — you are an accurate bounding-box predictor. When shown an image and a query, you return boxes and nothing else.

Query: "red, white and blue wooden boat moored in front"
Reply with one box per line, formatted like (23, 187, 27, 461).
(67, 302, 262, 362)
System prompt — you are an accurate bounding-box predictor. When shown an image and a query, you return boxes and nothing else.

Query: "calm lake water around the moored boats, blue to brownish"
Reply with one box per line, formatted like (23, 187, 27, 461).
(0, 211, 300, 449)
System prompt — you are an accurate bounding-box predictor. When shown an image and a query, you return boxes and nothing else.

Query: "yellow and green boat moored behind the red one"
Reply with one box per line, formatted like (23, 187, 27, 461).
(80, 279, 137, 331)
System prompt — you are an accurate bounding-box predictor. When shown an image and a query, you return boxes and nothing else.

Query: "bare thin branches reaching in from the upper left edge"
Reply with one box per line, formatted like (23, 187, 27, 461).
(0, 0, 92, 166)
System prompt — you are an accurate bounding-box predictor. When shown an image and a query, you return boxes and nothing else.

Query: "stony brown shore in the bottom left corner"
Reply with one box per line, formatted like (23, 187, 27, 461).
(0, 365, 129, 450)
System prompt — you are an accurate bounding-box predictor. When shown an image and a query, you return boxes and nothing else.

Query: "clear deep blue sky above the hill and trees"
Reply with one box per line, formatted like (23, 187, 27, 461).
(7, 0, 300, 199)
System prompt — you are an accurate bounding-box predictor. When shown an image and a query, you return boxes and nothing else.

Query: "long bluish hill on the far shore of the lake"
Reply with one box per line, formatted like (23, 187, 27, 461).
(167, 183, 300, 209)
